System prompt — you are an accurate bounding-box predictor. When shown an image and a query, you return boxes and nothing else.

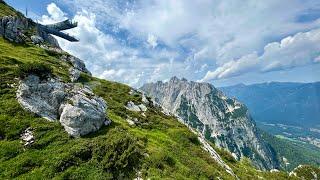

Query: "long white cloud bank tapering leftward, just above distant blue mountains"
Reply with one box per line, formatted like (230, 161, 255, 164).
(202, 29, 320, 81)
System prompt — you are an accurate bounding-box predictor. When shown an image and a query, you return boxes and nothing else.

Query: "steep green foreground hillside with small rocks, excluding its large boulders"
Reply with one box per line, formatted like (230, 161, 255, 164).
(0, 1, 320, 179)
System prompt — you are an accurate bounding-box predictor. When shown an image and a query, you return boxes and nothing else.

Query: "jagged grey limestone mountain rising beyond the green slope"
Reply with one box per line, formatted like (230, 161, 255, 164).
(141, 77, 278, 169)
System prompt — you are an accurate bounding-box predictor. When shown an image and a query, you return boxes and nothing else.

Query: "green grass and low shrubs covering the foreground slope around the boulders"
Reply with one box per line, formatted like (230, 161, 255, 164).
(0, 38, 230, 179)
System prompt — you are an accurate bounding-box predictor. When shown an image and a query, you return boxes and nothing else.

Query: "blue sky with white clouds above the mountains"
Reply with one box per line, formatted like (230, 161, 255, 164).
(6, 0, 320, 87)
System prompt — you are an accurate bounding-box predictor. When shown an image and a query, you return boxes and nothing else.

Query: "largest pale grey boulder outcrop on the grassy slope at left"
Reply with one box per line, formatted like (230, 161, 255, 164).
(17, 75, 107, 136)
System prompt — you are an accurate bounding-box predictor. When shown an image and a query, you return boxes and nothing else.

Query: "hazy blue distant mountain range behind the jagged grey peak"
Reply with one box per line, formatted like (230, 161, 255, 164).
(220, 82, 320, 128)
